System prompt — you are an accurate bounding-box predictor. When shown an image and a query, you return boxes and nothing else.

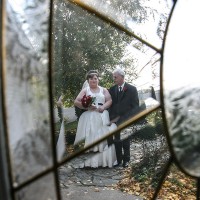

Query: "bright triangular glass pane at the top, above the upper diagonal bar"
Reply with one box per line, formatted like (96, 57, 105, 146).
(71, 0, 172, 48)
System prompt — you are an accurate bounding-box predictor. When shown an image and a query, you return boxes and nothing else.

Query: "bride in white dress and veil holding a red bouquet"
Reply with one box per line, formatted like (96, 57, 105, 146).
(74, 70, 117, 168)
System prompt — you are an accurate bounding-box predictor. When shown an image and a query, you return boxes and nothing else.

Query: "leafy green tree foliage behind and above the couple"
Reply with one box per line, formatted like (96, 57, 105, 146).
(53, 0, 162, 106)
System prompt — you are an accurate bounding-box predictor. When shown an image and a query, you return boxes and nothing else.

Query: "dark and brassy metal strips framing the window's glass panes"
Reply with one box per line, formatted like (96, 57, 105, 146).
(0, 0, 200, 200)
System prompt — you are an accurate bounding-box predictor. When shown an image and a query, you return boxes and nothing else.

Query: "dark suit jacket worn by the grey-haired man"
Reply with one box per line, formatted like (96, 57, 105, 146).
(109, 83, 139, 125)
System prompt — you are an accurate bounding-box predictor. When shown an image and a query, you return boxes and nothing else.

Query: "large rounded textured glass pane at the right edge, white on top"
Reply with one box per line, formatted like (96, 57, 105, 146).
(164, 0, 200, 177)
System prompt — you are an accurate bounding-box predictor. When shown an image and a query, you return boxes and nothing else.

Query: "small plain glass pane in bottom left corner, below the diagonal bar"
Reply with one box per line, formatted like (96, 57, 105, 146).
(15, 174, 57, 200)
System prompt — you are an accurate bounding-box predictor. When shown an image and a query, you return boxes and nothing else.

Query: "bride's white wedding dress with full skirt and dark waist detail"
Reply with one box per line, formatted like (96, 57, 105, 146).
(74, 86, 117, 168)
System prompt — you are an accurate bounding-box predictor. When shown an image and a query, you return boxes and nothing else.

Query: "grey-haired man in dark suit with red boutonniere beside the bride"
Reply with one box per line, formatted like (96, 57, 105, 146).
(109, 68, 139, 167)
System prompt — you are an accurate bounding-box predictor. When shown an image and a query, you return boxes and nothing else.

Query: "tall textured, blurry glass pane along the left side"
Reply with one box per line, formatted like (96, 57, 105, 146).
(4, 1, 52, 183)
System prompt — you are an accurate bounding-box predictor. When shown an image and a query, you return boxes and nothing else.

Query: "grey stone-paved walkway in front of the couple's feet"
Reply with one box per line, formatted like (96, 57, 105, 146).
(59, 145, 142, 200)
